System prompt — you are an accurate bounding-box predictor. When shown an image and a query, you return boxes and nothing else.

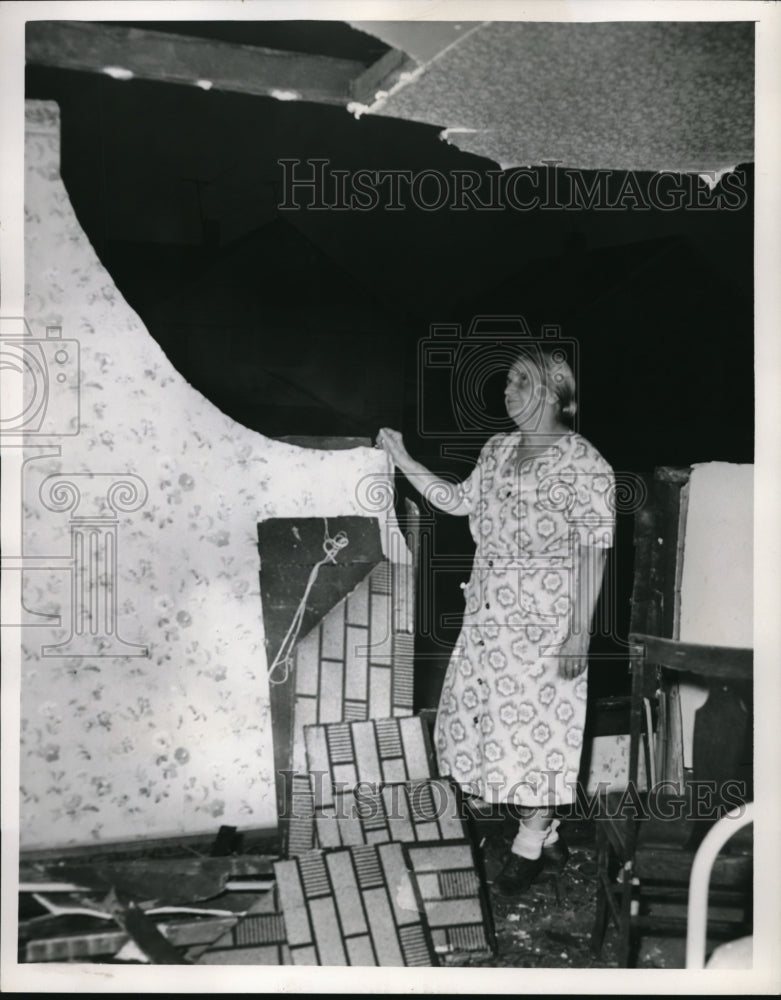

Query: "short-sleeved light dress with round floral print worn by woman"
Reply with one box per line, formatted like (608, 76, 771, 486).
(436, 432, 615, 807)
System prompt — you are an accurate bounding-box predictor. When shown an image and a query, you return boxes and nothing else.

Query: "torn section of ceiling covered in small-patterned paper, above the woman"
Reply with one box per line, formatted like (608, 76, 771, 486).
(350, 21, 754, 174)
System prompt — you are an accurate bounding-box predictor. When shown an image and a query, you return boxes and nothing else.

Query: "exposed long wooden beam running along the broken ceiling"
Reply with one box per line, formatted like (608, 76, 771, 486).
(26, 21, 408, 105)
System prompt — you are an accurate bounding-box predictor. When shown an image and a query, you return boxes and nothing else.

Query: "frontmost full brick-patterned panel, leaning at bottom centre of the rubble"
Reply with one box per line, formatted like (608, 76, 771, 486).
(274, 844, 437, 966)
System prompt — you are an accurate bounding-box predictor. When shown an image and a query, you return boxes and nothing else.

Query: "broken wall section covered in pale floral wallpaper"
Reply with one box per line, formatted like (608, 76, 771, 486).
(18, 101, 406, 848)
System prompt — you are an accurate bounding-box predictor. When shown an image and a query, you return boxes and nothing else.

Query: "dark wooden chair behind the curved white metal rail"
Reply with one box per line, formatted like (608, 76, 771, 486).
(592, 634, 753, 967)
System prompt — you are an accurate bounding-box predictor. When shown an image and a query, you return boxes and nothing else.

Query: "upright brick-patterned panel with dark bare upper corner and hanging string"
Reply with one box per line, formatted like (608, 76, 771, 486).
(259, 518, 414, 854)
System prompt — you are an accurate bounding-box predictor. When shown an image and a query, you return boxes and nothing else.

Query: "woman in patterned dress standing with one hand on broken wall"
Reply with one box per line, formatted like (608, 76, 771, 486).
(377, 344, 614, 898)
